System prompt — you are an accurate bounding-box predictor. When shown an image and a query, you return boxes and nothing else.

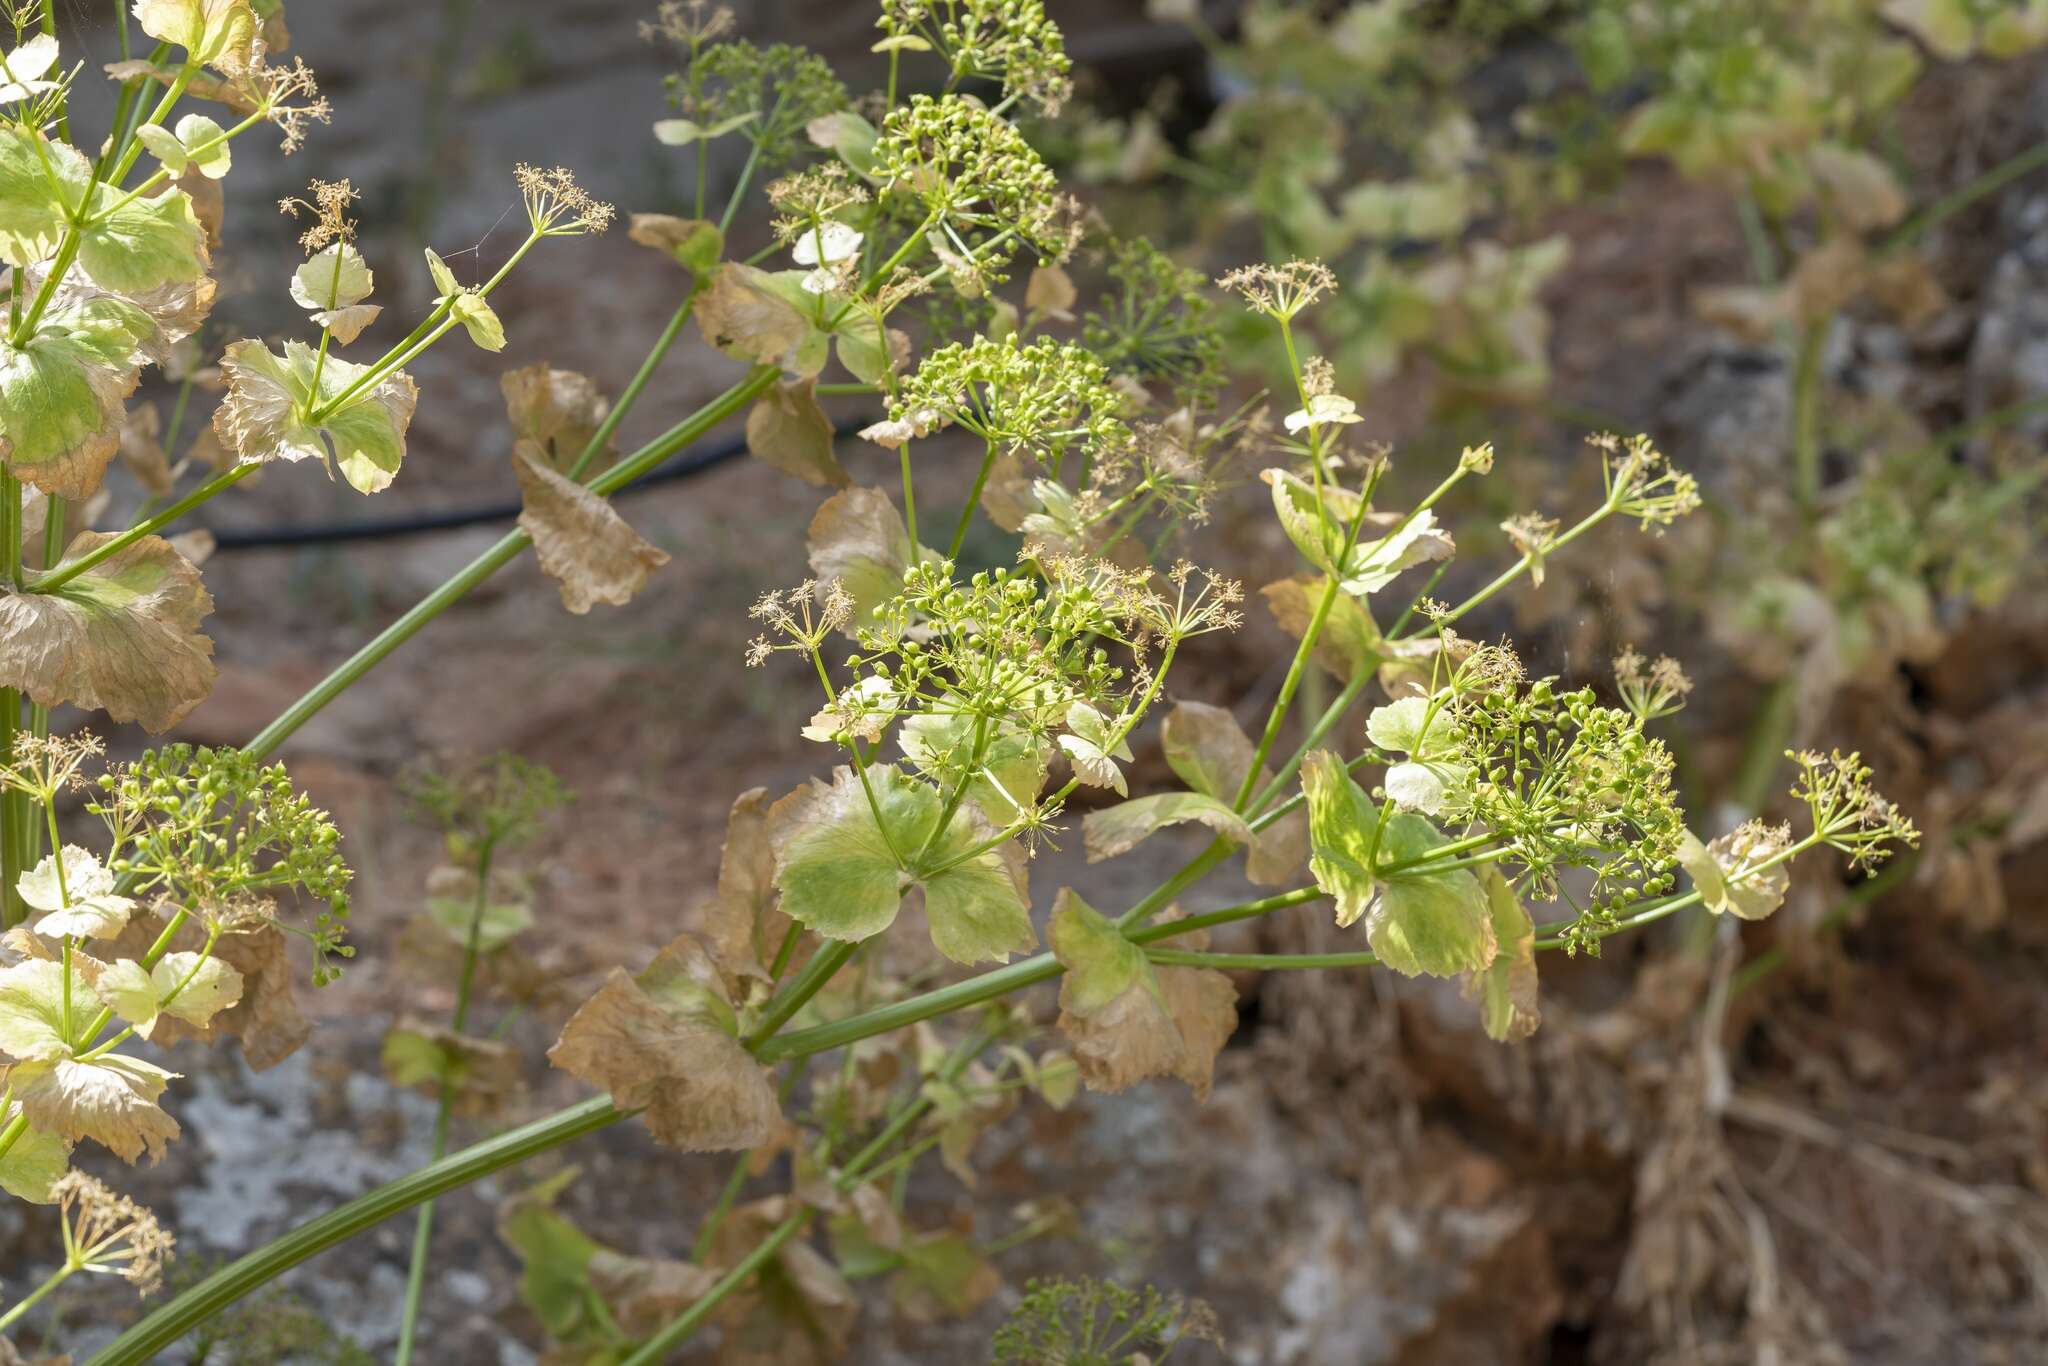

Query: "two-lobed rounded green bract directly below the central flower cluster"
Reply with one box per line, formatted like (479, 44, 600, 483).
(776, 764, 1038, 963)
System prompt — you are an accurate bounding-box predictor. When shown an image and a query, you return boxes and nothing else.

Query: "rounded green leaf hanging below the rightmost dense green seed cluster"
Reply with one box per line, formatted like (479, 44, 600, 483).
(1366, 811, 1497, 977)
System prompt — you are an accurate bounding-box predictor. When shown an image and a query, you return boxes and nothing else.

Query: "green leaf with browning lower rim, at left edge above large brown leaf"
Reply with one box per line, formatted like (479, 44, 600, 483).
(0, 295, 156, 502)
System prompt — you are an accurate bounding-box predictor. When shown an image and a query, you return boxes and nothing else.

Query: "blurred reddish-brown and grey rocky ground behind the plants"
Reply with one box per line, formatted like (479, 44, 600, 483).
(0, 0, 2048, 1366)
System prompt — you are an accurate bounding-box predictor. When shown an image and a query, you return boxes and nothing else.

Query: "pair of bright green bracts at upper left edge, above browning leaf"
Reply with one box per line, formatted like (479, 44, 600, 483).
(0, 127, 207, 293)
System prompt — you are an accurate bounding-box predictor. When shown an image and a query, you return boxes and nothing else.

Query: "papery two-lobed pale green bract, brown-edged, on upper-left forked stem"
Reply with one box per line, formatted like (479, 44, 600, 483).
(213, 340, 420, 494)
